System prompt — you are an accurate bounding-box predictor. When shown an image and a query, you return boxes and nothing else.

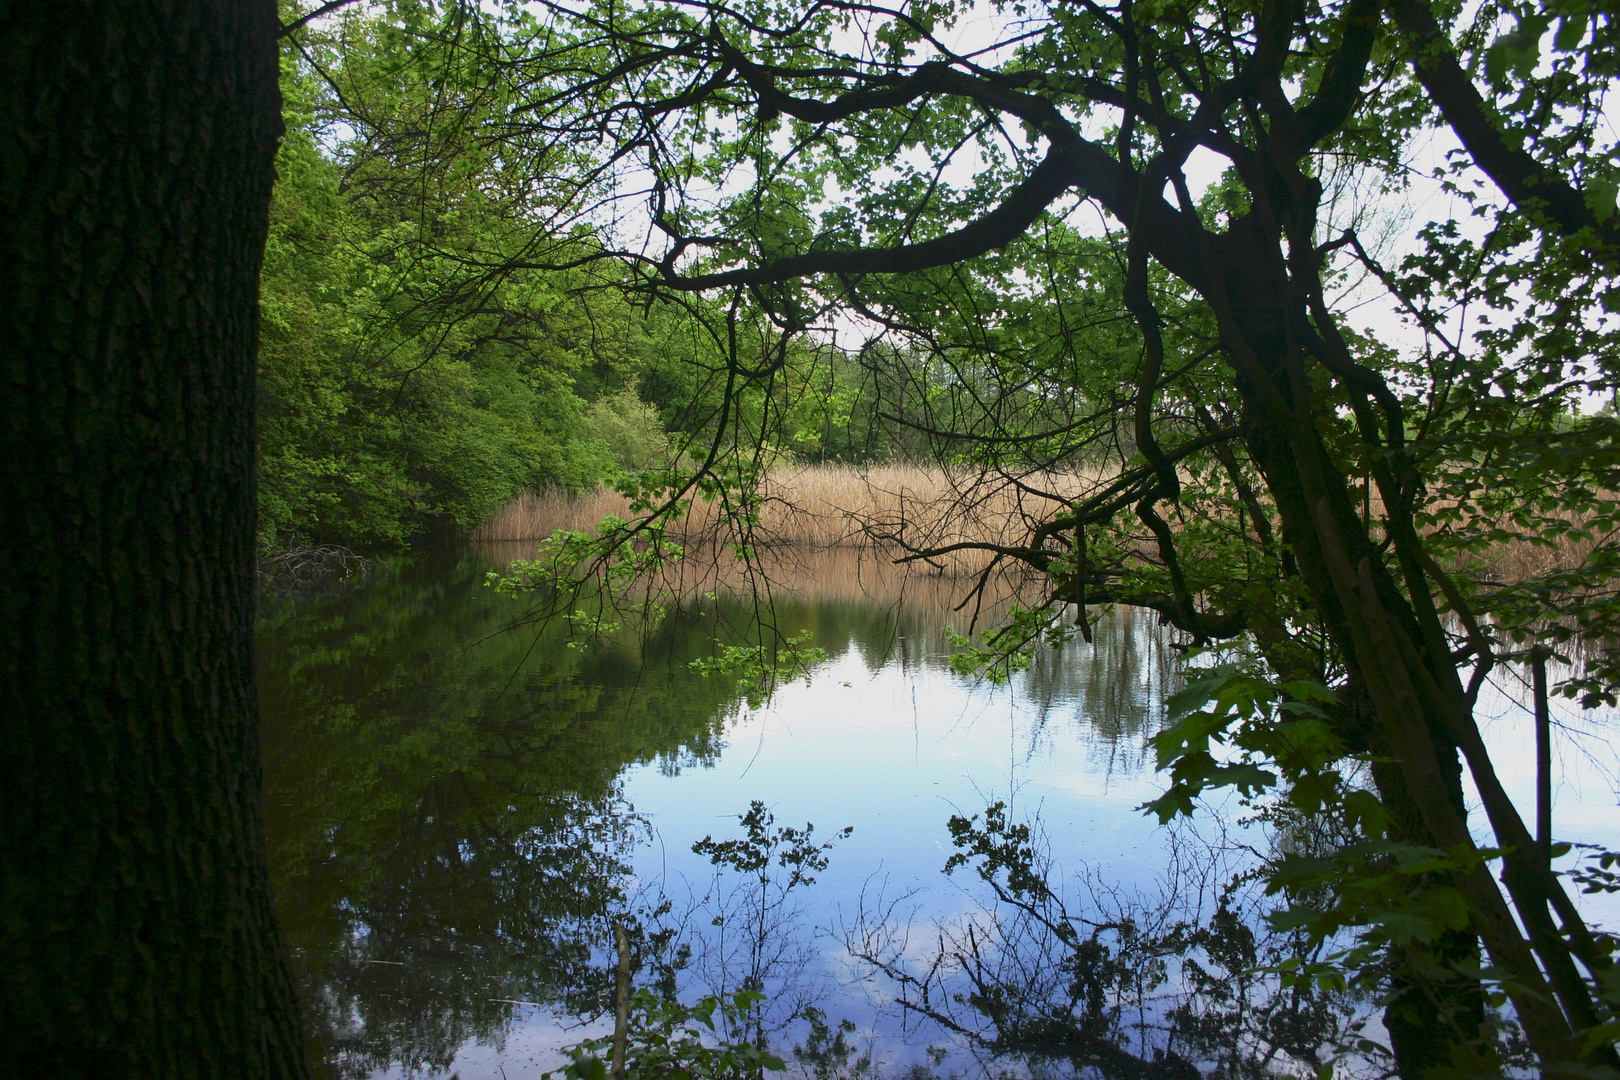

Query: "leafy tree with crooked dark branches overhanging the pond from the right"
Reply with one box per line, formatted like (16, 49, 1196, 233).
(281, 0, 1620, 1075)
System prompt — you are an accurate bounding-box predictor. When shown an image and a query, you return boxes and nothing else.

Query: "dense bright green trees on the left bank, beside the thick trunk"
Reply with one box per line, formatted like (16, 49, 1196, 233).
(259, 40, 672, 551)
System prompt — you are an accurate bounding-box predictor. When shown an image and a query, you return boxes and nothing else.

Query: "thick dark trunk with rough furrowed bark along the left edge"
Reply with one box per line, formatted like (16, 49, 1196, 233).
(0, 0, 308, 1078)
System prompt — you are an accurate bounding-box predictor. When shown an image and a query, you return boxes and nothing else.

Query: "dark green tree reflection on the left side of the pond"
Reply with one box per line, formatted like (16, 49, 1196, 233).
(259, 559, 741, 1075)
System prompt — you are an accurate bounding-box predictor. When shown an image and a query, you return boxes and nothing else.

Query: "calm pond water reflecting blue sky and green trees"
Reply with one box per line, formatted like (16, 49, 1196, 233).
(259, 549, 1620, 1080)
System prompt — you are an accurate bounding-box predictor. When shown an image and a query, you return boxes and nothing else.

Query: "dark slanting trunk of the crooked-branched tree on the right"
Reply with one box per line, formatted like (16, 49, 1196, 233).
(1199, 208, 1612, 1075)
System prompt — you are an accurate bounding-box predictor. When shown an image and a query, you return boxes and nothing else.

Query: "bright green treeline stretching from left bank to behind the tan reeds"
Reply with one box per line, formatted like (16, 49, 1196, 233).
(258, 29, 930, 554)
